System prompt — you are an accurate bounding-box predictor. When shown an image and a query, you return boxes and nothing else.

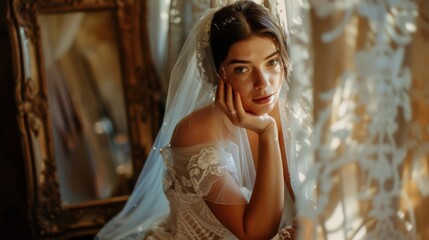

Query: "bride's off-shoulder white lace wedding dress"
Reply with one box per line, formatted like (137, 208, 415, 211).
(146, 142, 294, 240)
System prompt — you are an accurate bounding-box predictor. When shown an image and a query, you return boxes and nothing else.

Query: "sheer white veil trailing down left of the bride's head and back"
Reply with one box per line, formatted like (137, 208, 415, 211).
(97, 8, 224, 239)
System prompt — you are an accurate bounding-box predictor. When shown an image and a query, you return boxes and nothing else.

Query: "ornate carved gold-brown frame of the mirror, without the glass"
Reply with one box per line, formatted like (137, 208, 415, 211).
(7, 0, 161, 239)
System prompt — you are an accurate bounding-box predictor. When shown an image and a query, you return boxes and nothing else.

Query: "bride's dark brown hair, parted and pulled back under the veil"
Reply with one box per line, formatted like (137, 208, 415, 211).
(210, 1, 288, 70)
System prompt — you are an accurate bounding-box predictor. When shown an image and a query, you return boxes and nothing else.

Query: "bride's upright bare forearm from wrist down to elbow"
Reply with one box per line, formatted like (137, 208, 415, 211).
(243, 124, 285, 238)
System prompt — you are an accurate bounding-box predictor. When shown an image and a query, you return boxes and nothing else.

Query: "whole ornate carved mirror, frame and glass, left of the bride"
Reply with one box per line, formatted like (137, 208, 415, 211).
(8, 0, 162, 239)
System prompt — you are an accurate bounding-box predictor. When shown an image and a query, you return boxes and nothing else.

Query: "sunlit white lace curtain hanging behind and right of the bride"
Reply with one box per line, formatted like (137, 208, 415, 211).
(145, 0, 429, 239)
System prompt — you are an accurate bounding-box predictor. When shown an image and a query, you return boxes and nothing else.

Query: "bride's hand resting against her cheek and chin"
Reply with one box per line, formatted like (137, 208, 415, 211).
(216, 79, 276, 134)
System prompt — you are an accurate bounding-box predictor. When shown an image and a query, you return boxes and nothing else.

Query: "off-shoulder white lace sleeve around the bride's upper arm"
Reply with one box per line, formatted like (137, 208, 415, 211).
(187, 147, 236, 197)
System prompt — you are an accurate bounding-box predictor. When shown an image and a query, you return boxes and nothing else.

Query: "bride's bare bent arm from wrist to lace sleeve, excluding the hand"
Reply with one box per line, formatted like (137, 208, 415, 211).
(206, 123, 284, 239)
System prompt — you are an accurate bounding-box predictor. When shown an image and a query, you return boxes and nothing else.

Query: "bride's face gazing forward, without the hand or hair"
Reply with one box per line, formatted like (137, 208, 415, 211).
(221, 36, 284, 115)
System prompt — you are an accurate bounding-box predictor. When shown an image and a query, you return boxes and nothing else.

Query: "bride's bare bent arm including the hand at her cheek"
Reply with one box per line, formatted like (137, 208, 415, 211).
(206, 83, 284, 239)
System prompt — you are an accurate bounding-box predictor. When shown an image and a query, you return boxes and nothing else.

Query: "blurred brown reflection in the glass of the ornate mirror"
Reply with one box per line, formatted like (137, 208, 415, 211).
(38, 11, 133, 204)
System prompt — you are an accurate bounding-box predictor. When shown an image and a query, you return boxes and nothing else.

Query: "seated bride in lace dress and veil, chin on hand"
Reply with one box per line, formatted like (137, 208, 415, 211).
(98, 1, 294, 239)
